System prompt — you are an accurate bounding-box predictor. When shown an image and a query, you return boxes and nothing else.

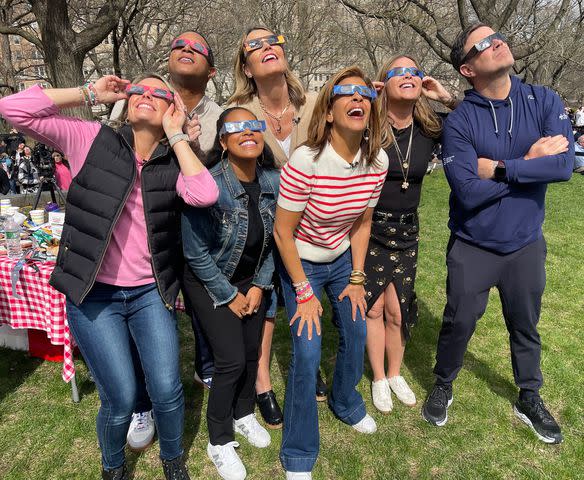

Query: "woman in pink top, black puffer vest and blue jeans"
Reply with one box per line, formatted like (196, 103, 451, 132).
(0, 74, 218, 480)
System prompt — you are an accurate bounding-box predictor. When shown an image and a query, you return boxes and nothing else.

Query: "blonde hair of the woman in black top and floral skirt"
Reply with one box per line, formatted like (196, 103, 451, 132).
(377, 55, 442, 148)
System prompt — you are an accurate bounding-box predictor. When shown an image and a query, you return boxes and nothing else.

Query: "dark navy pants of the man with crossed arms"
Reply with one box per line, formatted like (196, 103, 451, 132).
(434, 236, 547, 394)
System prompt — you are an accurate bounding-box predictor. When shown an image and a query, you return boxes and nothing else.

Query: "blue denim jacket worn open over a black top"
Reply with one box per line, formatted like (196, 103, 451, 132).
(182, 160, 280, 307)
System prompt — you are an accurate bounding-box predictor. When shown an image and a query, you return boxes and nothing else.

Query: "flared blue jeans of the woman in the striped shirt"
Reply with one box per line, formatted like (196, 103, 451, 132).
(278, 251, 367, 472)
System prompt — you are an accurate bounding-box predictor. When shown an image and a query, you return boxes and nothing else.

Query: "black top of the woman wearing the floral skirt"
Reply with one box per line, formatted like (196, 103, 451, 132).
(376, 122, 438, 213)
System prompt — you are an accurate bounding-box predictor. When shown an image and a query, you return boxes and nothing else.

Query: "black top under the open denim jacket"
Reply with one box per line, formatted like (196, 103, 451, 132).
(231, 178, 264, 284)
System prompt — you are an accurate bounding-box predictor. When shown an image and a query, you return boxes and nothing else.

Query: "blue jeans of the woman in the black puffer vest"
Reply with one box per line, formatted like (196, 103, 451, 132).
(67, 283, 184, 469)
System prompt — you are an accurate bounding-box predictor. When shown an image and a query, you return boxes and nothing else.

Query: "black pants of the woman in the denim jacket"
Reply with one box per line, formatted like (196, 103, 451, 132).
(191, 280, 271, 445)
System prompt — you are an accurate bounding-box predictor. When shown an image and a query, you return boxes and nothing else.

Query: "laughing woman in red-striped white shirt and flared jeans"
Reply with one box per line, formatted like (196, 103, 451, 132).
(274, 67, 388, 479)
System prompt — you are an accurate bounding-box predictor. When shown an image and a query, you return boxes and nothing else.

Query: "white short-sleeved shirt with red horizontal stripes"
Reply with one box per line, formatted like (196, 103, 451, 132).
(278, 143, 389, 263)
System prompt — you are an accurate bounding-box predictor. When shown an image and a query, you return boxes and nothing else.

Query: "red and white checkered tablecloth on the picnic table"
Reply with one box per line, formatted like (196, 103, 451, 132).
(0, 256, 75, 382)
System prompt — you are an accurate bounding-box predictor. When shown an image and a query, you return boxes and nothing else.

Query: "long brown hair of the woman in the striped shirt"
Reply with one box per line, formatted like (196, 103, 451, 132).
(305, 65, 381, 165)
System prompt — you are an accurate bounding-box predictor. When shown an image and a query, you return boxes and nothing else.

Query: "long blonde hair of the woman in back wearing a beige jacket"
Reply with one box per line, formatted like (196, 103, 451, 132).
(227, 27, 306, 110)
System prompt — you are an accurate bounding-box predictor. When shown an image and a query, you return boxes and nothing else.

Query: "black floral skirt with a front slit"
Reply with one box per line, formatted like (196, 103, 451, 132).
(365, 210, 420, 340)
